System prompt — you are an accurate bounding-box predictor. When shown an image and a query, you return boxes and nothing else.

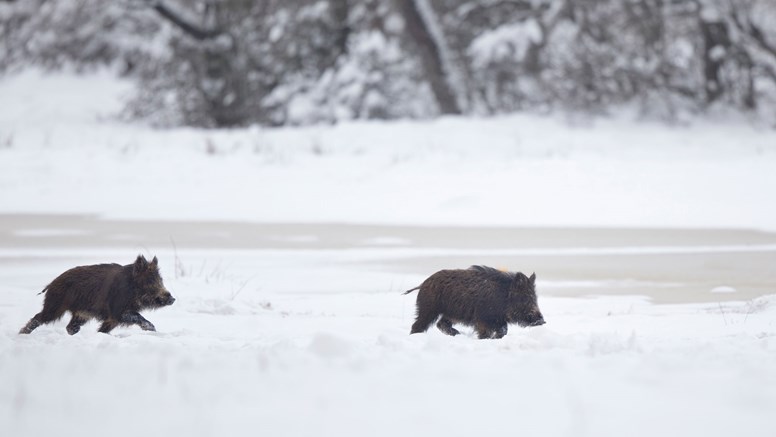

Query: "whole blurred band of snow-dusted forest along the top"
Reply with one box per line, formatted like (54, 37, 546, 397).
(0, 0, 776, 127)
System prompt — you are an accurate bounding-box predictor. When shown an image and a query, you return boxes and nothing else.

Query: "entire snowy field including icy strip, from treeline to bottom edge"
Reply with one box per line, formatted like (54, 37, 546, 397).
(0, 73, 776, 437)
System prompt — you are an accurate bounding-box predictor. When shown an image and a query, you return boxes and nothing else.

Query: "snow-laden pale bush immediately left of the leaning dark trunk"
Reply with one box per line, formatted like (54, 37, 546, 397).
(268, 0, 438, 124)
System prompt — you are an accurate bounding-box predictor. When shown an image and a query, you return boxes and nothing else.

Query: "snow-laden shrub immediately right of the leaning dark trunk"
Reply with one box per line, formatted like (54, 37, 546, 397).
(442, 0, 569, 113)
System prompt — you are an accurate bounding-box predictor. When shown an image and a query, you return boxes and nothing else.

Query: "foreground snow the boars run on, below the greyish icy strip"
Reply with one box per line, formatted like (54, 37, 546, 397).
(0, 245, 776, 436)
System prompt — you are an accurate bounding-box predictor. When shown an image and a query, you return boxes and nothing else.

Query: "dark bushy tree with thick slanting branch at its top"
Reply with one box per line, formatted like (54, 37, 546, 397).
(132, 1, 258, 127)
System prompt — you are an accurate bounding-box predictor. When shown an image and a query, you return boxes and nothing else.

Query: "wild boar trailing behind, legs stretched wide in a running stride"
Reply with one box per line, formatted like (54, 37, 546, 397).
(19, 255, 175, 335)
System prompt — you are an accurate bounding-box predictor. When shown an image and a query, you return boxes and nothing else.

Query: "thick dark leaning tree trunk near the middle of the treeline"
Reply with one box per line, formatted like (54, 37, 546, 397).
(396, 0, 461, 114)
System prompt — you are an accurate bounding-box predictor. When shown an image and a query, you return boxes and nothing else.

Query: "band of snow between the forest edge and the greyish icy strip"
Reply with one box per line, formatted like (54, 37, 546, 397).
(0, 73, 776, 230)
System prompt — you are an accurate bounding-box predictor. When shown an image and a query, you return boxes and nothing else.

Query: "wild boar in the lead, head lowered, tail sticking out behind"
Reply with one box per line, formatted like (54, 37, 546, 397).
(404, 266, 544, 338)
